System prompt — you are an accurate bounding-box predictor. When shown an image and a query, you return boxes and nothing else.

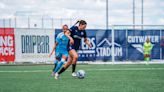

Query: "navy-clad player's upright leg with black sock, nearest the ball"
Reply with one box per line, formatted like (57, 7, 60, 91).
(69, 49, 78, 76)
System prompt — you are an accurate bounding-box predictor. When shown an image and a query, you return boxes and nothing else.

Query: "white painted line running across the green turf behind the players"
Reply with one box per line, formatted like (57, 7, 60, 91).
(0, 68, 164, 73)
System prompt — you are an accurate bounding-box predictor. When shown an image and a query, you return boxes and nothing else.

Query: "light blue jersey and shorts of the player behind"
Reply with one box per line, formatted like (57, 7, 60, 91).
(56, 32, 69, 57)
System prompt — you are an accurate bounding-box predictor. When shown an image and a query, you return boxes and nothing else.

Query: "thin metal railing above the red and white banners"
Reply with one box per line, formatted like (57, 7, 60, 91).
(0, 17, 76, 29)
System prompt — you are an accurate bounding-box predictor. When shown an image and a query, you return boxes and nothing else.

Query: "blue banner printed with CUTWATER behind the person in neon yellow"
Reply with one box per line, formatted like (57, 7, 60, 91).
(127, 30, 160, 60)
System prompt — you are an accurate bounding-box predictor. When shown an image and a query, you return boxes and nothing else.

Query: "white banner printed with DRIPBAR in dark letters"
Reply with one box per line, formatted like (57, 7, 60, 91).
(15, 29, 55, 62)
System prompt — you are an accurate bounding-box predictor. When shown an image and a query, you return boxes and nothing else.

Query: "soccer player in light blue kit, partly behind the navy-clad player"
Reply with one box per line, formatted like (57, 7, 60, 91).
(49, 25, 74, 79)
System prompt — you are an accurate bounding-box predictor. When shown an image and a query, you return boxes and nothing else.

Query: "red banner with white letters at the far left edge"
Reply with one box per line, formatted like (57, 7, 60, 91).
(0, 28, 15, 62)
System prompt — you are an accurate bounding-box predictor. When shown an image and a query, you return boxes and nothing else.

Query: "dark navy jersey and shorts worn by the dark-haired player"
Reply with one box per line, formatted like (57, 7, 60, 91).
(70, 26, 87, 50)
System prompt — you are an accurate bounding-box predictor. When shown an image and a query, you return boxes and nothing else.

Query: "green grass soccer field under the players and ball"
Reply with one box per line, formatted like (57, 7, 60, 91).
(0, 64, 164, 92)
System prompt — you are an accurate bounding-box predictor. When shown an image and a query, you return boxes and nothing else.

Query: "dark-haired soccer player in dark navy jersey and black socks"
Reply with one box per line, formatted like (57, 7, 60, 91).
(55, 20, 92, 77)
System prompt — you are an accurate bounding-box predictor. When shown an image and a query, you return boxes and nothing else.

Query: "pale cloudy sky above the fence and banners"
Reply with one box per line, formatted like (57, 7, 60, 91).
(0, 0, 164, 28)
